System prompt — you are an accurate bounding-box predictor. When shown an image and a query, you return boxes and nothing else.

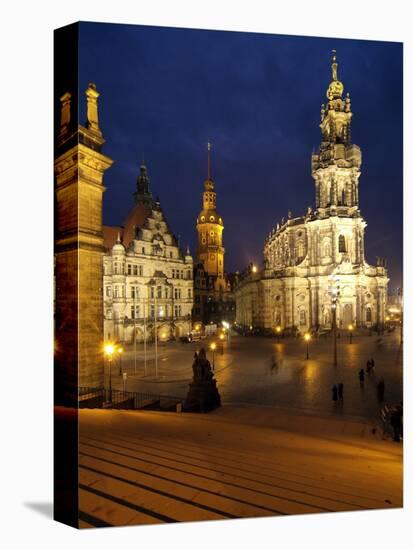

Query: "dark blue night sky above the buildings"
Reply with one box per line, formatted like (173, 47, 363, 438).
(79, 23, 403, 292)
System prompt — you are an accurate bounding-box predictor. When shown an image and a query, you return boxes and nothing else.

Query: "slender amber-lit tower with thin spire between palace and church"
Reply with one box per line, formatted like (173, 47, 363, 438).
(193, 143, 235, 323)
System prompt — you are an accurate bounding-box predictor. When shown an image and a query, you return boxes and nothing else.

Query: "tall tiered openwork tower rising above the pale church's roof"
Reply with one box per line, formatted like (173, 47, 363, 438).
(311, 50, 361, 217)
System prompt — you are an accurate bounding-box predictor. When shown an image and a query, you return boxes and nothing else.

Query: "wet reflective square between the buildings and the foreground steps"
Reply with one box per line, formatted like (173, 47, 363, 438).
(108, 332, 403, 421)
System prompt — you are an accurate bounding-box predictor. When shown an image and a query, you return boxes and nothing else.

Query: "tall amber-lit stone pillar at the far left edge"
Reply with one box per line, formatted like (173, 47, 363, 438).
(55, 84, 113, 401)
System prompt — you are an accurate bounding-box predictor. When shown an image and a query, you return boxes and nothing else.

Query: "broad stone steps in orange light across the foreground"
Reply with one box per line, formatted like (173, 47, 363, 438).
(75, 405, 402, 528)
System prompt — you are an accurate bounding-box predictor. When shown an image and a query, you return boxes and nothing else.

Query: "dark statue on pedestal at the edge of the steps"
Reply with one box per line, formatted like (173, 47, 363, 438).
(183, 348, 221, 412)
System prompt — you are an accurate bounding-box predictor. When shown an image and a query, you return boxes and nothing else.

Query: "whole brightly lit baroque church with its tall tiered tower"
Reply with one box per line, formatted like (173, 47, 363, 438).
(236, 52, 389, 332)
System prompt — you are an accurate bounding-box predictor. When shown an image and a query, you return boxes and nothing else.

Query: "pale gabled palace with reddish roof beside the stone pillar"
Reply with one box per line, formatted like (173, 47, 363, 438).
(103, 163, 194, 343)
